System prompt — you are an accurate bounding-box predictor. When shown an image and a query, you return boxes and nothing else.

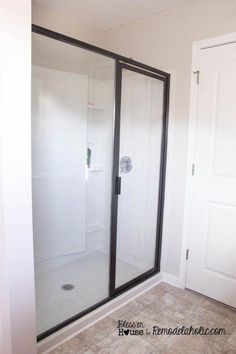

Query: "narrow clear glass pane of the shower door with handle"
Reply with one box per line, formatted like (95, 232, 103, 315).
(116, 69, 163, 288)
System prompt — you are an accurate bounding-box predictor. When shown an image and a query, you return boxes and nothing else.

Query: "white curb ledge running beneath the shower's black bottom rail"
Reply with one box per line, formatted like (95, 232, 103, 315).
(37, 273, 162, 354)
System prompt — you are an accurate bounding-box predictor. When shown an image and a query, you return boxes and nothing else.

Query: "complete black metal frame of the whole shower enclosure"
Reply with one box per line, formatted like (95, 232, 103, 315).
(32, 25, 170, 341)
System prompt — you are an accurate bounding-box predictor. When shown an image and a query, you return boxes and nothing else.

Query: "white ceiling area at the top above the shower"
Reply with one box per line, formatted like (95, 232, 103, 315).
(34, 0, 193, 31)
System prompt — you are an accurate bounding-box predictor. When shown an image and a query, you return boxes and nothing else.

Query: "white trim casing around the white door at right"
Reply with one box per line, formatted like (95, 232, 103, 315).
(179, 32, 236, 288)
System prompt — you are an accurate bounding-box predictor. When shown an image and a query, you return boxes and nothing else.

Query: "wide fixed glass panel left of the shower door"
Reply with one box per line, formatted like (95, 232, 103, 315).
(32, 34, 114, 334)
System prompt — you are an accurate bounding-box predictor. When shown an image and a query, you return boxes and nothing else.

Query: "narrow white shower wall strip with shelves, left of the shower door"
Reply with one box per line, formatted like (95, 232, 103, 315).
(86, 77, 114, 255)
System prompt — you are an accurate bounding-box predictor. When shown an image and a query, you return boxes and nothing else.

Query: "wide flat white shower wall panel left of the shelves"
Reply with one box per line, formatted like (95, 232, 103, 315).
(32, 66, 88, 261)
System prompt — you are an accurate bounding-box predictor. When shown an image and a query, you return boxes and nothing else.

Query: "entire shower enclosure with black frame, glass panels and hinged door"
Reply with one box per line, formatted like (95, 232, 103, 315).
(32, 25, 170, 340)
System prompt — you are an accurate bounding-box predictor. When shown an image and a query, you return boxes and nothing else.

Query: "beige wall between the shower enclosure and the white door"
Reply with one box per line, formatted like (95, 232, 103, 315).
(105, 0, 236, 275)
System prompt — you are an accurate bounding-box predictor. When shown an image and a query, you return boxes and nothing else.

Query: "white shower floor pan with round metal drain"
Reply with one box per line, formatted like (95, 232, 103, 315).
(35, 252, 142, 334)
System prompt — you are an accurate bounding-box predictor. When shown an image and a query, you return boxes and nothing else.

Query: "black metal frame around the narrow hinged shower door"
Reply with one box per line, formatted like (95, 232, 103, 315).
(110, 60, 170, 298)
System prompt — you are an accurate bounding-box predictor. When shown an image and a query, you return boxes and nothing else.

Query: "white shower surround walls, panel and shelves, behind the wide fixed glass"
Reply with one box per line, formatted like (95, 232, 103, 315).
(32, 65, 114, 271)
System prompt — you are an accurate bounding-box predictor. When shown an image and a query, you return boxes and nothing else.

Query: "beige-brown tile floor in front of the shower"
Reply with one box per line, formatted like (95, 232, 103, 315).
(50, 283, 236, 354)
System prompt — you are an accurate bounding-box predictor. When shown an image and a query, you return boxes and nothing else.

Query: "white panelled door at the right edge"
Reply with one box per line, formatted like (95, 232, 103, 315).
(187, 43, 236, 307)
